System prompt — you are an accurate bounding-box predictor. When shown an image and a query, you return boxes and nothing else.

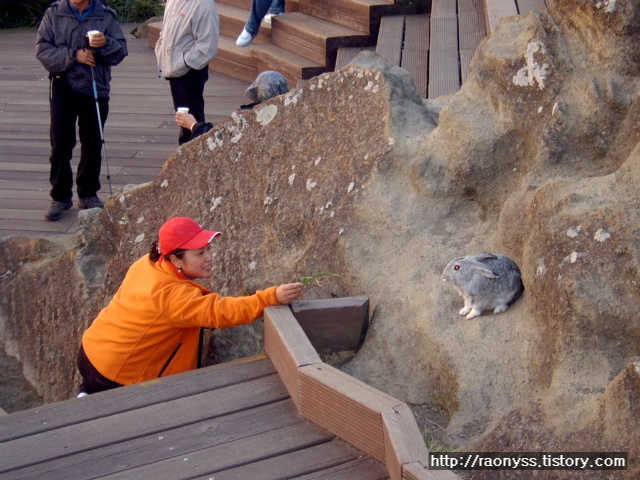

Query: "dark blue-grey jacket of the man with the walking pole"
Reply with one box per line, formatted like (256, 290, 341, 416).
(36, 0, 128, 98)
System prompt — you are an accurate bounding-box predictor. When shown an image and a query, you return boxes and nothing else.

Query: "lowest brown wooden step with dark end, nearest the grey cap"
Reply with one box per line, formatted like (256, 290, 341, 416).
(251, 43, 330, 86)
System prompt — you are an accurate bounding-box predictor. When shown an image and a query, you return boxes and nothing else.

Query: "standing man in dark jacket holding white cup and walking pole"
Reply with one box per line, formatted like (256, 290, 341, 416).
(36, 0, 128, 221)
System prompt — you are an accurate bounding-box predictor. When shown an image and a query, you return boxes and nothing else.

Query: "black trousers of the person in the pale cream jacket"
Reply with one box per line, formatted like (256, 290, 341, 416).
(168, 66, 209, 145)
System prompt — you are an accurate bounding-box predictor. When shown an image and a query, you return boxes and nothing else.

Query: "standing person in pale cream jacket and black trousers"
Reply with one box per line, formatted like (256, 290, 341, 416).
(155, 0, 220, 145)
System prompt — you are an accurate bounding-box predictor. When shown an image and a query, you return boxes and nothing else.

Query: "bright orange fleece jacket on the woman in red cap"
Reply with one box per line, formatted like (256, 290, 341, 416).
(82, 255, 278, 385)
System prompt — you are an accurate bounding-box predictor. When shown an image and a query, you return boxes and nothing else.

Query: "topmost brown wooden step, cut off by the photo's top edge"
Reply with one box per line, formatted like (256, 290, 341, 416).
(300, 0, 398, 35)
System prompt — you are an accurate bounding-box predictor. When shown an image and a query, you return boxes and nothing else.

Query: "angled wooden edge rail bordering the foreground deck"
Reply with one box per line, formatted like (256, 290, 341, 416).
(264, 305, 458, 480)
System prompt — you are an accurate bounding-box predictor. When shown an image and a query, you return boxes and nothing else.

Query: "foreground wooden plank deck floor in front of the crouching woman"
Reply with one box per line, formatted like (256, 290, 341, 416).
(0, 355, 388, 480)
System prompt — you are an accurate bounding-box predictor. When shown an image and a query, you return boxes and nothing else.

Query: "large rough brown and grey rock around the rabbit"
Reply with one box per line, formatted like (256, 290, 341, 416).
(0, 0, 640, 479)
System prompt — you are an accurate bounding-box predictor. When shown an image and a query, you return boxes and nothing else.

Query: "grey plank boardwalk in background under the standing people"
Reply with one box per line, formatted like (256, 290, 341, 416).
(0, 25, 249, 238)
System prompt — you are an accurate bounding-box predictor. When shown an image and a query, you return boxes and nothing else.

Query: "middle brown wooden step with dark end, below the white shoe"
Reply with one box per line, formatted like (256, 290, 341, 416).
(271, 12, 372, 70)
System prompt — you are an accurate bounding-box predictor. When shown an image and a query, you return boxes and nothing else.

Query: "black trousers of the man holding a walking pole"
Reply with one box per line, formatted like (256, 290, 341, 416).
(49, 76, 109, 202)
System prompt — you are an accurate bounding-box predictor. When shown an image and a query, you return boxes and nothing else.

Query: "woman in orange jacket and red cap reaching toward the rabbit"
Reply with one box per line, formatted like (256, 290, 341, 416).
(78, 217, 304, 396)
